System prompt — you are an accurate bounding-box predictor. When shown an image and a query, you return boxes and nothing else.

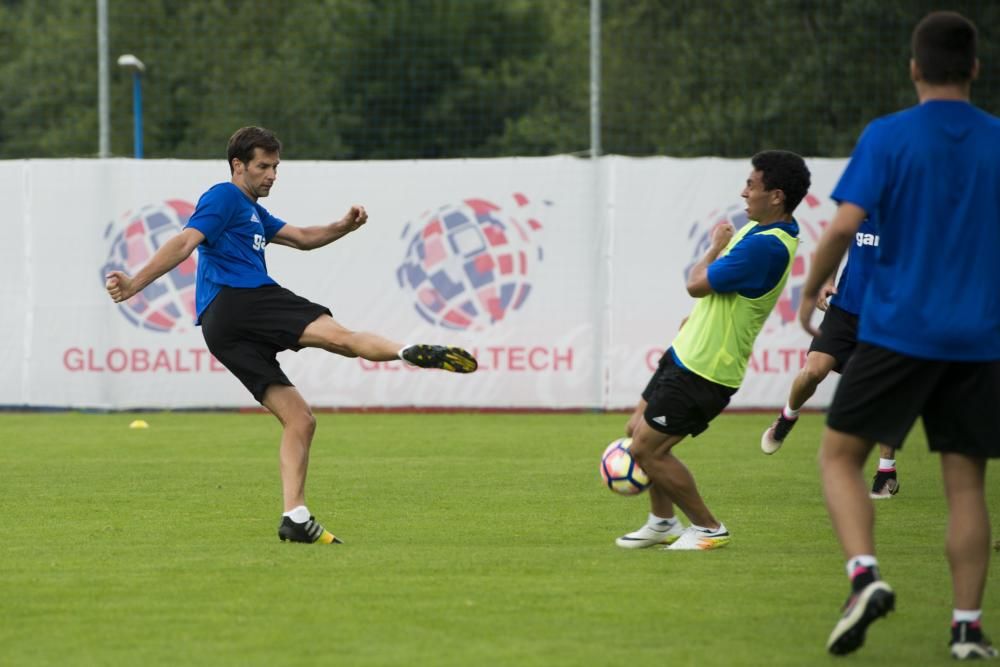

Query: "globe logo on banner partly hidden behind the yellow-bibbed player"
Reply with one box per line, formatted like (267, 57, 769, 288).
(684, 194, 829, 333)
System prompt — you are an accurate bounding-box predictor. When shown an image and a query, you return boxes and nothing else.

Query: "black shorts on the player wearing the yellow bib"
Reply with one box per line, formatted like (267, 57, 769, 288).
(642, 350, 736, 436)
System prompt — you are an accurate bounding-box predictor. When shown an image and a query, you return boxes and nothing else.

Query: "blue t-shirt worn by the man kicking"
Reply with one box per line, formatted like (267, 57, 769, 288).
(187, 183, 285, 323)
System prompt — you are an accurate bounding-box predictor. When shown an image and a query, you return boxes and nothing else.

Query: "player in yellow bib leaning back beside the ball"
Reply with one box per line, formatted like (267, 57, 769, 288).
(616, 151, 810, 550)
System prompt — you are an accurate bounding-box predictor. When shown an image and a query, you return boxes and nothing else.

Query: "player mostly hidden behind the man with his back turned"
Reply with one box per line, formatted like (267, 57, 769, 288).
(760, 218, 899, 499)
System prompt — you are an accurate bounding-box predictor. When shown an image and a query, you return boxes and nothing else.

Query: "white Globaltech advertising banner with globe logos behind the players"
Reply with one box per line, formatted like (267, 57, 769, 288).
(0, 156, 843, 409)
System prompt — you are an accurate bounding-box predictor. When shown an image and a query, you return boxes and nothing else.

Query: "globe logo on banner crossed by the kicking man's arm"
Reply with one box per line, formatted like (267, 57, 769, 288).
(100, 199, 198, 332)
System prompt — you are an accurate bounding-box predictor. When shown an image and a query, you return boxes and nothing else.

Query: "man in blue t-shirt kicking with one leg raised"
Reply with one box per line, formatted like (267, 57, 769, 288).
(107, 127, 477, 544)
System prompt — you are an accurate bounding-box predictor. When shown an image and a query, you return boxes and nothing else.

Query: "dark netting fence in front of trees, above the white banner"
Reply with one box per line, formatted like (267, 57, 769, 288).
(0, 0, 1000, 159)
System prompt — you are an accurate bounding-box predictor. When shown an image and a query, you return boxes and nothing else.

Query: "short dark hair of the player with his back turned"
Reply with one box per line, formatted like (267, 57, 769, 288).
(911, 12, 976, 85)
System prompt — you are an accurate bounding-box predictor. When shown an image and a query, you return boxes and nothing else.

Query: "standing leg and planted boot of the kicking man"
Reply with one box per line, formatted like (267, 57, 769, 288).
(262, 384, 341, 544)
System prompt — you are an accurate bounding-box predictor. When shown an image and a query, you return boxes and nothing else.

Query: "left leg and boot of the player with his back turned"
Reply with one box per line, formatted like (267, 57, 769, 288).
(819, 427, 896, 655)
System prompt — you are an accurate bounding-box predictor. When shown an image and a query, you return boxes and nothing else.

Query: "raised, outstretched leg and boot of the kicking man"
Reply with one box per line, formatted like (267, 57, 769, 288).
(299, 315, 479, 373)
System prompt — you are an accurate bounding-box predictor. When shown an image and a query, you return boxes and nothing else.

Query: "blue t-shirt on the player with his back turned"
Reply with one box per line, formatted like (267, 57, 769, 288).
(833, 100, 1000, 361)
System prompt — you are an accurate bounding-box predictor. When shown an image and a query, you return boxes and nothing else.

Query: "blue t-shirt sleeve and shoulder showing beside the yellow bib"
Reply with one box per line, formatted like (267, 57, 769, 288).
(708, 220, 799, 299)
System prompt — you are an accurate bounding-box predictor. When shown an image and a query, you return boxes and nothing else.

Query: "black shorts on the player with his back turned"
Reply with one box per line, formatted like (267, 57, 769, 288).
(826, 343, 1000, 458)
